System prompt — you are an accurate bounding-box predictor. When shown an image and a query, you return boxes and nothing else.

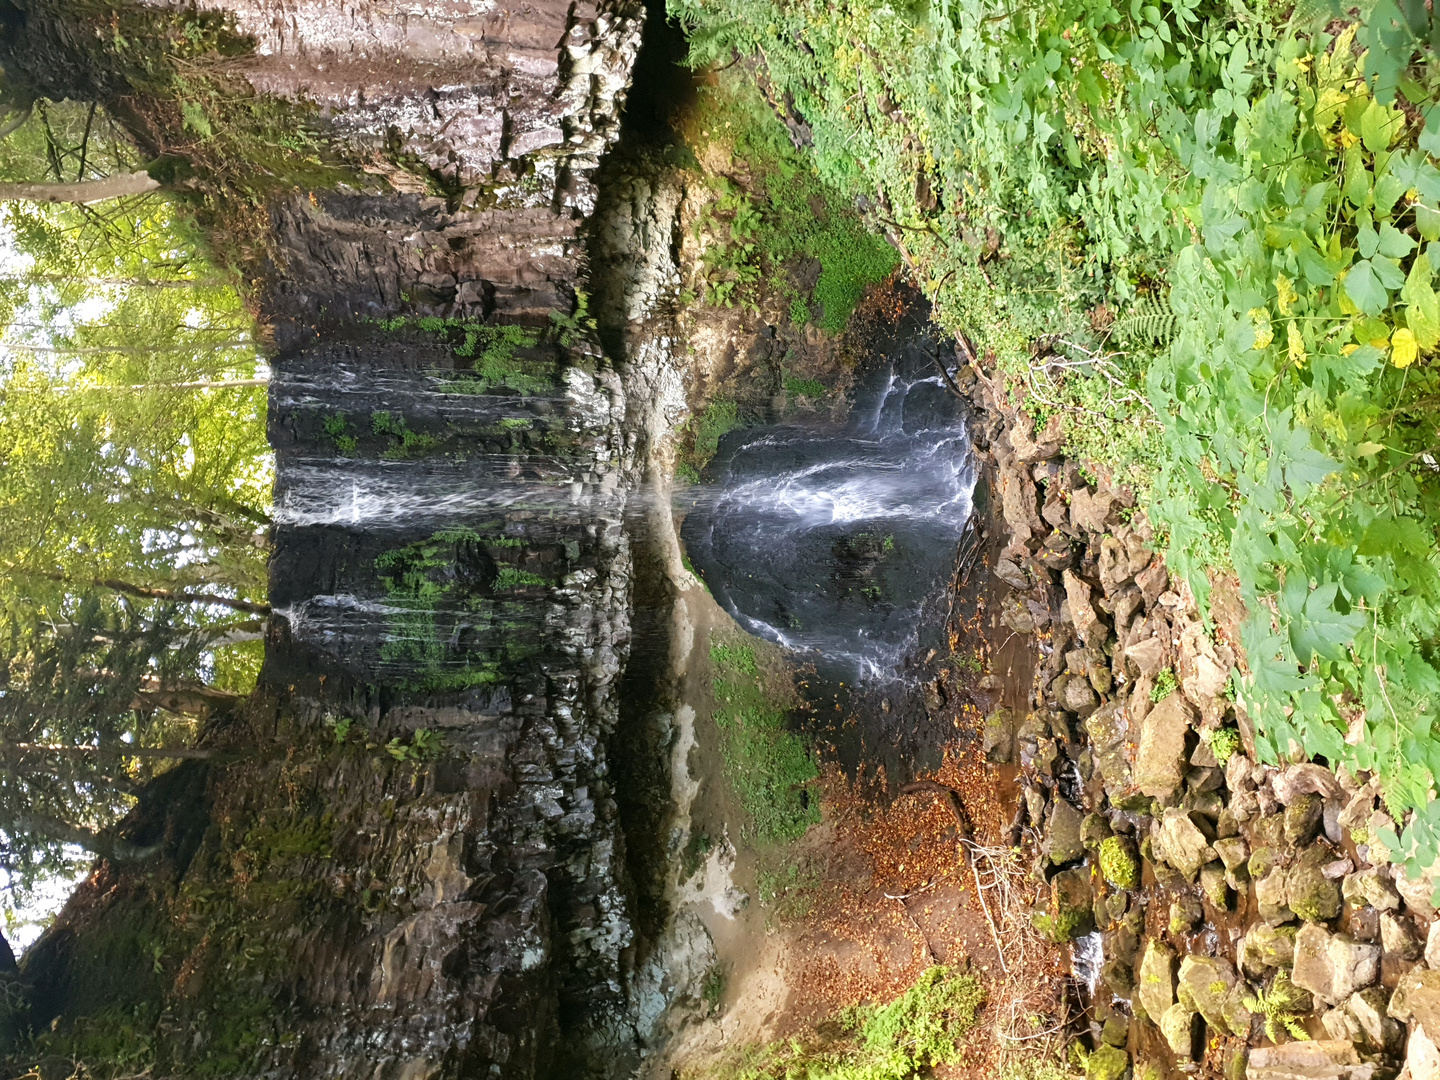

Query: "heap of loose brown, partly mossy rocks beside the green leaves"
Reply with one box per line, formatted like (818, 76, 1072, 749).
(966, 367, 1440, 1080)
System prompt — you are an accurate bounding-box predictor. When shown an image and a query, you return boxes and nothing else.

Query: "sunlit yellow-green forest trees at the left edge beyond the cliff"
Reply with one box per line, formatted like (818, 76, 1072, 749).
(0, 99, 272, 933)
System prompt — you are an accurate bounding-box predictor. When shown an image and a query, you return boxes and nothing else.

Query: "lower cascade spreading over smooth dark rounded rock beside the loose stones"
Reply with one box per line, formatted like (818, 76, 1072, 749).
(683, 319, 975, 684)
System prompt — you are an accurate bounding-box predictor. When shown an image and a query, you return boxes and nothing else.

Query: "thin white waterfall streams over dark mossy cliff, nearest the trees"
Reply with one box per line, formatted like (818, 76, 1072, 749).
(271, 330, 624, 693)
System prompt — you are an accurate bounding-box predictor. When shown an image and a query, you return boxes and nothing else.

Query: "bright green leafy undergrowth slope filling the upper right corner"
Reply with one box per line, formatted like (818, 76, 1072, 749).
(678, 0, 1440, 873)
